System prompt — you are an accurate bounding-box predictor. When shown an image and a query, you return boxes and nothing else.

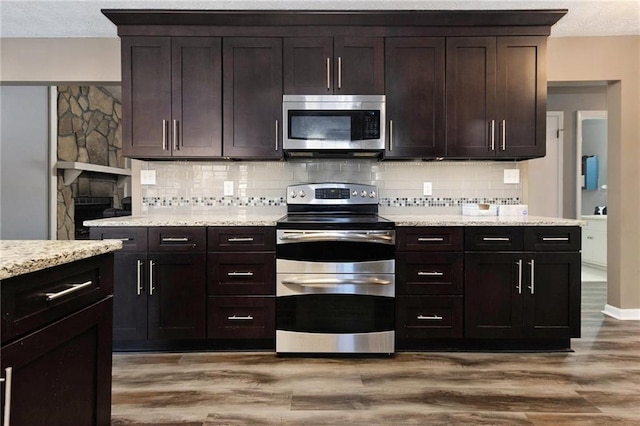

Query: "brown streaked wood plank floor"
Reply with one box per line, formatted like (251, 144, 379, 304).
(112, 282, 640, 426)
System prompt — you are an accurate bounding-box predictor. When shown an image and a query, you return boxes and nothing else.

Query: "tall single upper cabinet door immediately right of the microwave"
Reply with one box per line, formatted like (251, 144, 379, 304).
(385, 37, 445, 158)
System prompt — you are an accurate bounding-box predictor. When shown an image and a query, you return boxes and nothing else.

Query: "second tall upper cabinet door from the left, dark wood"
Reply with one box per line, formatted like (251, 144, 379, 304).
(170, 37, 222, 157)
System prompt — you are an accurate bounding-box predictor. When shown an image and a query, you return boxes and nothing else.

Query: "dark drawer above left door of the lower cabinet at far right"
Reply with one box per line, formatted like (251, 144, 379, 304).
(464, 226, 524, 251)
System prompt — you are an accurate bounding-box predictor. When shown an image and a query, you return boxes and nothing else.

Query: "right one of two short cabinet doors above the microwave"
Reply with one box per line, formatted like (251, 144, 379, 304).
(333, 37, 384, 95)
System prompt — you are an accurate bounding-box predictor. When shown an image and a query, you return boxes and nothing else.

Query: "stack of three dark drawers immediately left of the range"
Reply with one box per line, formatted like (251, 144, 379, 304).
(207, 226, 275, 349)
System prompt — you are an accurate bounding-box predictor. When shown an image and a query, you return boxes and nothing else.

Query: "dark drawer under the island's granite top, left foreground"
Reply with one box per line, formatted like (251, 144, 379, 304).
(2, 253, 113, 343)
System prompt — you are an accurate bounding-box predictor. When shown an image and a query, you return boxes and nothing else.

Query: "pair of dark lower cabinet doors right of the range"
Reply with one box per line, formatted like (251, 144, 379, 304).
(464, 252, 580, 339)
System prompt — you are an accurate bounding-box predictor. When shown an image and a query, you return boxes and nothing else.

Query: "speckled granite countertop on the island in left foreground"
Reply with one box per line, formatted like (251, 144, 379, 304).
(0, 240, 122, 280)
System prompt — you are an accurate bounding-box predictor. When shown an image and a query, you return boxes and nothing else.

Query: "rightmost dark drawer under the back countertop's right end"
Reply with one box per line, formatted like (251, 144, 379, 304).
(524, 226, 582, 251)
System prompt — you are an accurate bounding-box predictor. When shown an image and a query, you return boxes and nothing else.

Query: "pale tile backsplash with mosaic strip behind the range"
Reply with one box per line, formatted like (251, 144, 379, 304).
(140, 159, 522, 215)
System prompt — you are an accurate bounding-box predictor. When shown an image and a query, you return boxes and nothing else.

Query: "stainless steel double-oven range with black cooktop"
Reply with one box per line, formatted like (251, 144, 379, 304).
(276, 183, 395, 354)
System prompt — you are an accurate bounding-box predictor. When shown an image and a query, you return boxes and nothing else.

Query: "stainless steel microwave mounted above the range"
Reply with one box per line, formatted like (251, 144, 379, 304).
(282, 95, 385, 156)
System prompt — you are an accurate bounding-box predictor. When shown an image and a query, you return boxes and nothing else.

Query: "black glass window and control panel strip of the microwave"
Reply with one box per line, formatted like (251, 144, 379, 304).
(287, 110, 380, 141)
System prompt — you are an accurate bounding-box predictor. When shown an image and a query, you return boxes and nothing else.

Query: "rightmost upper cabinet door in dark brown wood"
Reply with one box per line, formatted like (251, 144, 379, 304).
(496, 37, 547, 158)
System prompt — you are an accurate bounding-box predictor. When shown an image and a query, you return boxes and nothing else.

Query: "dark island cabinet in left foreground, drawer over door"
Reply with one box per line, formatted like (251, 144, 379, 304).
(0, 253, 113, 426)
